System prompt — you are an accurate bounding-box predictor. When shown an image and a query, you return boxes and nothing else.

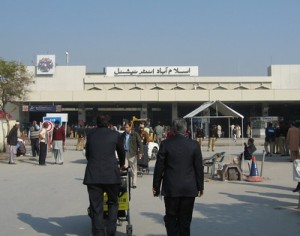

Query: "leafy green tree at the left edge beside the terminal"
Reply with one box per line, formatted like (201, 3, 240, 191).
(0, 58, 34, 152)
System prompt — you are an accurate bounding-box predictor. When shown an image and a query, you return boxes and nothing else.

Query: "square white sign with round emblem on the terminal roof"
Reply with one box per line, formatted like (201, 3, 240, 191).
(36, 55, 55, 75)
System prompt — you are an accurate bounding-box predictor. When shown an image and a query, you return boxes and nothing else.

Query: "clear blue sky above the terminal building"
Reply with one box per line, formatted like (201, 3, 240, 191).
(0, 0, 300, 76)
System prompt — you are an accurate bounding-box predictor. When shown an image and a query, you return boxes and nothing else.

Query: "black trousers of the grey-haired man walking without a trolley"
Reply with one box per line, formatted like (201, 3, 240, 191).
(164, 197, 195, 236)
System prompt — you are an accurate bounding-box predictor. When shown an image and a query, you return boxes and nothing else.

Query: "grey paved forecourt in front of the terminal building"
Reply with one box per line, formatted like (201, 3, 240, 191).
(0, 139, 300, 236)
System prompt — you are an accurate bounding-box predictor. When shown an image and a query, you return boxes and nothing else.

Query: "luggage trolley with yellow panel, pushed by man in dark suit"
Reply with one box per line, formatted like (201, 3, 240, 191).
(88, 168, 132, 236)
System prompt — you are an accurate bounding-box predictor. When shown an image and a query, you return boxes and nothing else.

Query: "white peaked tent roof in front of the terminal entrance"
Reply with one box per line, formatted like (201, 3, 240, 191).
(183, 100, 244, 119)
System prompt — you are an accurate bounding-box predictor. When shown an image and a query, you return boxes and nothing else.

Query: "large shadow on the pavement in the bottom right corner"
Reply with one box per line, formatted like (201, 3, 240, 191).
(192, 192, 299, 236)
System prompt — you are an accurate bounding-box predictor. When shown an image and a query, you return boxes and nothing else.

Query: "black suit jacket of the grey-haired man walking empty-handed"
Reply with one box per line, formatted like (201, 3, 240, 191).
(153, 134, 204, 197)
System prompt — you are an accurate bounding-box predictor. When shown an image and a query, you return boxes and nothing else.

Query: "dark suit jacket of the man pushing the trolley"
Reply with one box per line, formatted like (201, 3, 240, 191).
(83, 128, 125, 185)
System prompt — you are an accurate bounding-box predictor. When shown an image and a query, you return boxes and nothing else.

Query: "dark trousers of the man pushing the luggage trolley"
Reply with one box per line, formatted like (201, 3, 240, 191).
(87, 184, 120, 236)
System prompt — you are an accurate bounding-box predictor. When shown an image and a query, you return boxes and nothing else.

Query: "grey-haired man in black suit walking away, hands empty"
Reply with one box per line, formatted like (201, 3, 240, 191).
(152, 119, 204, 236)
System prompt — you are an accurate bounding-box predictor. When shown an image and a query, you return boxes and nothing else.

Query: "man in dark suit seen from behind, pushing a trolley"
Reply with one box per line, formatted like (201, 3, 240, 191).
(83, 114, 125, 236)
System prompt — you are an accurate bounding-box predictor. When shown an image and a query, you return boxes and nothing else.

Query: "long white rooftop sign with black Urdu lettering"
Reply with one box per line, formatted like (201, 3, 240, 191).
(106, 66, 198, 76)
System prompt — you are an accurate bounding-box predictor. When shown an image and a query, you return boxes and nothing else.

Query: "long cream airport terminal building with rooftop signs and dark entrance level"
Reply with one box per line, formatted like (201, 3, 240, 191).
(9, 55, 300, 136)
